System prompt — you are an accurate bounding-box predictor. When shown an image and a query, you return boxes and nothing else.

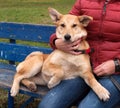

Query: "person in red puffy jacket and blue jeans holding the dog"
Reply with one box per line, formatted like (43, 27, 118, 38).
(38, 0, 120, 108)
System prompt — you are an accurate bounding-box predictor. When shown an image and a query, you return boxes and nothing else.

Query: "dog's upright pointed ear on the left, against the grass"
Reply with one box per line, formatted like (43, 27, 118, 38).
(48, 8, 62, 22)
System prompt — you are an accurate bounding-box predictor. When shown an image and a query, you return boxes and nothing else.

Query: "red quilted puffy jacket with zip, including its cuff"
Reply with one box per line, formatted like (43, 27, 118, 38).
(50, 0, 120, 67)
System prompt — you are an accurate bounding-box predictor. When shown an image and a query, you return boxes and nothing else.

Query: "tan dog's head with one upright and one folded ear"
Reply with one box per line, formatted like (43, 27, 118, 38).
(48, 8, 93, 42)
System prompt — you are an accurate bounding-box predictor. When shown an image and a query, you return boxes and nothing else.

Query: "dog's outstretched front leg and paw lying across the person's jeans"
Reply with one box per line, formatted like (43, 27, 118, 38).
(82, 71, 110, 101)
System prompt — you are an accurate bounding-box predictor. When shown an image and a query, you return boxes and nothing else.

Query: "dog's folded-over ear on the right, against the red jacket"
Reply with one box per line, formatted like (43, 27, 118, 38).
(78, 15, 93, 27)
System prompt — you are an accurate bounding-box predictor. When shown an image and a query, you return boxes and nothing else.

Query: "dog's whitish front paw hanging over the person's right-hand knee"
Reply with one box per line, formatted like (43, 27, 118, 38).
(98, 87, 110, 101)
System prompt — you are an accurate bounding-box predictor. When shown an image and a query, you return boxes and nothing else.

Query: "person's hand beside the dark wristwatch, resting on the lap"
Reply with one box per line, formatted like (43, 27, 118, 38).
(93, 60, 115, 76)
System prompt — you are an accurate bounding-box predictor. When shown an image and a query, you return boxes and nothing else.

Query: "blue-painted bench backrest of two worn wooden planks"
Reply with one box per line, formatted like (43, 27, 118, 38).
(0, 22, 55, 64)
